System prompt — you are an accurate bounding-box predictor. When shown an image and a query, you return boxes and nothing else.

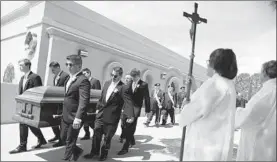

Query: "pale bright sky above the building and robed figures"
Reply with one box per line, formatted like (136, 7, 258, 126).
(1, 1, 276, 74)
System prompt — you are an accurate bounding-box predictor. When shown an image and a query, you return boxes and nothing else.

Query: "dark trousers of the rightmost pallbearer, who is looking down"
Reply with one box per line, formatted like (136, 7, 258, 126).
(123, 114, 138, 150)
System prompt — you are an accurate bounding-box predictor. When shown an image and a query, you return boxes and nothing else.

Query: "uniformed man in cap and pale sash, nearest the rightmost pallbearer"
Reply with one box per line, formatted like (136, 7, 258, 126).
(144, 83, 164, 126)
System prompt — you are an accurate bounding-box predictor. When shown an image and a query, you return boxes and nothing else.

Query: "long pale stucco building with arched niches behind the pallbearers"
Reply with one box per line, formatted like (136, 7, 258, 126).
(1, 1, 206, 123)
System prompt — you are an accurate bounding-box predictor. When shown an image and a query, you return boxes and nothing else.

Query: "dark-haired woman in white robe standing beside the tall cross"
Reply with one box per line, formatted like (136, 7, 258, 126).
(180, 49, 238, 161)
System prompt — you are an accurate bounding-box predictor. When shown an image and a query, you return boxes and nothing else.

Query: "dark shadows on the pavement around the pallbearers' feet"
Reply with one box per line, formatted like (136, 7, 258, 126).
(36, 135, 165, 161)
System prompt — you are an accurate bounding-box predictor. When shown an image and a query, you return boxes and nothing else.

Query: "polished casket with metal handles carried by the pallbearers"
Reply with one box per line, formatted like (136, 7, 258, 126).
(13, 86, 101, 128)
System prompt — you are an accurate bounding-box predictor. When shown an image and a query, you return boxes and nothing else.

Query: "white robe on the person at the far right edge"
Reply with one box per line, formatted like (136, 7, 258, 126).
(236, 79, 276, 161)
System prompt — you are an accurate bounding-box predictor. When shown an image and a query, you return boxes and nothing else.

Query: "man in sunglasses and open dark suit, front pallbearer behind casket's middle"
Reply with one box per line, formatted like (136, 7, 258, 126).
(84, 67, 133, 161)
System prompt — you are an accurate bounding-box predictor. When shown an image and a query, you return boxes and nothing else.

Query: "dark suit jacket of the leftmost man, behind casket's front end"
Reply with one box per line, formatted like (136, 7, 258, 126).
(18, 71, 42, 95)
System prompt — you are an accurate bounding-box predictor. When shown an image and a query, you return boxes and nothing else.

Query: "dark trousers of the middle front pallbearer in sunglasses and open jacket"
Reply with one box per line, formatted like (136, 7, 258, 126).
(91, 121, 118, 154)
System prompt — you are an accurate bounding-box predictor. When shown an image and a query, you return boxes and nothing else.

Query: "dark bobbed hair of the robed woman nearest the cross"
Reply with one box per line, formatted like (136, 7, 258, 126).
(209, 48, 238, 79)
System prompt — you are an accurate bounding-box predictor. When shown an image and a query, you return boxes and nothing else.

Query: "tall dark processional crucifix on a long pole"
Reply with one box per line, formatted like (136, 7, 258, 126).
(179, 3, 207, 161)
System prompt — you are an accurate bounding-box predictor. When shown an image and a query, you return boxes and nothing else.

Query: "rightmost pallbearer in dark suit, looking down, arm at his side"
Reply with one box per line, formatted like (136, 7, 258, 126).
(118, 68, 150, 155)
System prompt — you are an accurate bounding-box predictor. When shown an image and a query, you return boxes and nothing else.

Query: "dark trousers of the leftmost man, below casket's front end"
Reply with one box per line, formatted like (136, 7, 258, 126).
(19, 123, 45, 147)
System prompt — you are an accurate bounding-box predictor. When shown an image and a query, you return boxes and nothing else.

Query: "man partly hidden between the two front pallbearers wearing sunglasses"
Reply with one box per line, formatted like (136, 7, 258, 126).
(81, 68, 101, 140)
